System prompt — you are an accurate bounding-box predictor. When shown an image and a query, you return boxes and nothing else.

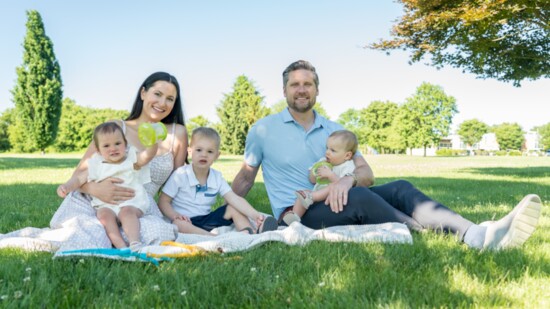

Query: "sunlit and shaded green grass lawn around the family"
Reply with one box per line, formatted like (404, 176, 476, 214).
(0, 155, 550, 308)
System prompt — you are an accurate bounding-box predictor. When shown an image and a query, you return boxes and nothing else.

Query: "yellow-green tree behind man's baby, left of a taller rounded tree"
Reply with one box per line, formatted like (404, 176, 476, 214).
(363, 101, 398, 153)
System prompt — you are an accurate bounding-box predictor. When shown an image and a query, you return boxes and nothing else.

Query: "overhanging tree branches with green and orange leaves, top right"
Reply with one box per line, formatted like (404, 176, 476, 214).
(368, 0, 550, 86)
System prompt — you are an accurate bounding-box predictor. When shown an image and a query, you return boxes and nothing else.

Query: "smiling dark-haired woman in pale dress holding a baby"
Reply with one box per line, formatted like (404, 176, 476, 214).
(50, 72, 188, 250)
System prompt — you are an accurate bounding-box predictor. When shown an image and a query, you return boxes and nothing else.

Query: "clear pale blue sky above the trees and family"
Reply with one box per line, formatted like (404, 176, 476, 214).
(0, 0, 550, 130)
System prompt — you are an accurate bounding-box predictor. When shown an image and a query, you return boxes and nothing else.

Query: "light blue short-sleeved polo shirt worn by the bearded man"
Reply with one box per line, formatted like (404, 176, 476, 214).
(244, 108, 343, 218)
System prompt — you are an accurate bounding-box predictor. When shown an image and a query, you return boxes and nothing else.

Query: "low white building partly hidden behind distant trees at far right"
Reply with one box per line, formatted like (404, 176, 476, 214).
(412, 131, 542, 156)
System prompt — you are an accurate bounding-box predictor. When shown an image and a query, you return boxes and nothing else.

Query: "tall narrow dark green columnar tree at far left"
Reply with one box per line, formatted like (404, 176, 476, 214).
(12, 11, 63, 153)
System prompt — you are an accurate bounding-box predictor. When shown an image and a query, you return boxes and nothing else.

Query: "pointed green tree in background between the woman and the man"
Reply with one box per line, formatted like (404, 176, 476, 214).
(216, 75, 269, 154)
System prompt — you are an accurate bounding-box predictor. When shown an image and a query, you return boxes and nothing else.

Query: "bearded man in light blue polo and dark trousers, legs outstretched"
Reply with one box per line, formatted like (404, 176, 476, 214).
(232, 60, 541, 249)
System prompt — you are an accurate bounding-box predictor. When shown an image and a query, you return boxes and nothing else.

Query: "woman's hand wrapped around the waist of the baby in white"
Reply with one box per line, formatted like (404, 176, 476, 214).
(84, 177, 135, 205)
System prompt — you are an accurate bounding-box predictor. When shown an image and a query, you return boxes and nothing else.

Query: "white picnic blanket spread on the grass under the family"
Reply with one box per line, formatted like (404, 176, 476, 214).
(0, 220, 412, 253)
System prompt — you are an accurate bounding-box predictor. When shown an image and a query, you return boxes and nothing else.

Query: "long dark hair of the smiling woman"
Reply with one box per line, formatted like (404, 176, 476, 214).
(126, 72, 185, 125)
